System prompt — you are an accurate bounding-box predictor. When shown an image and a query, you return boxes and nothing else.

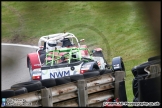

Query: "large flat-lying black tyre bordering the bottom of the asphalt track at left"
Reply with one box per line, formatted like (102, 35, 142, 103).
(11, 80, 42, 92)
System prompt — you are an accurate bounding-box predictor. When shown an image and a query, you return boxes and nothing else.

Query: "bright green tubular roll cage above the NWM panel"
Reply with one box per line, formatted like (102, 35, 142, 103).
(45, 48, 94, 66)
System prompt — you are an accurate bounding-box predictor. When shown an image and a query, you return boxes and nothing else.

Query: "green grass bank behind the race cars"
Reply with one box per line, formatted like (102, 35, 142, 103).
(1, 1, 158, 102)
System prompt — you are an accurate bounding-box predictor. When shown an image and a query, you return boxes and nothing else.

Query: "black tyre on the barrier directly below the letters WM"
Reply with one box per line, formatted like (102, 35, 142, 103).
(55, 76, 71, 86)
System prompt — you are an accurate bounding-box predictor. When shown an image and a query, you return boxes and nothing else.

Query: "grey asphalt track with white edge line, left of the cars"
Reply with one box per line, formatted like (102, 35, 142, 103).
(1, 43, 38, 90)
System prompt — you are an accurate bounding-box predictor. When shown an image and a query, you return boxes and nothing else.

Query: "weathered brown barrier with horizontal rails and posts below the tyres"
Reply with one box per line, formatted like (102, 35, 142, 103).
(3, 71, 125, 107)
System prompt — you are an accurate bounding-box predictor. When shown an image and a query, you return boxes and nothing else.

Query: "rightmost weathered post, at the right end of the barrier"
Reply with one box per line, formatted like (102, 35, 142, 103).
(114, 71, 125, 99)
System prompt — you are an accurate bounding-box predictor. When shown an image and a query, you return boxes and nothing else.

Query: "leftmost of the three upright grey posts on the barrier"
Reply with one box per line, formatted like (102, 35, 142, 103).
(41, 88, 53, 107)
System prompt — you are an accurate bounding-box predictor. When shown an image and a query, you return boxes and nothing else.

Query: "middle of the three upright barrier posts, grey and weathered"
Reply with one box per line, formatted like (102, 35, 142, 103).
(77, 79, 88, 107)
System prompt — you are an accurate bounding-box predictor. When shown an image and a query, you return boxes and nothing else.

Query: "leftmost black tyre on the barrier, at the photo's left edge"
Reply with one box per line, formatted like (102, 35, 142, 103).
(1, 89, 15, 98)
